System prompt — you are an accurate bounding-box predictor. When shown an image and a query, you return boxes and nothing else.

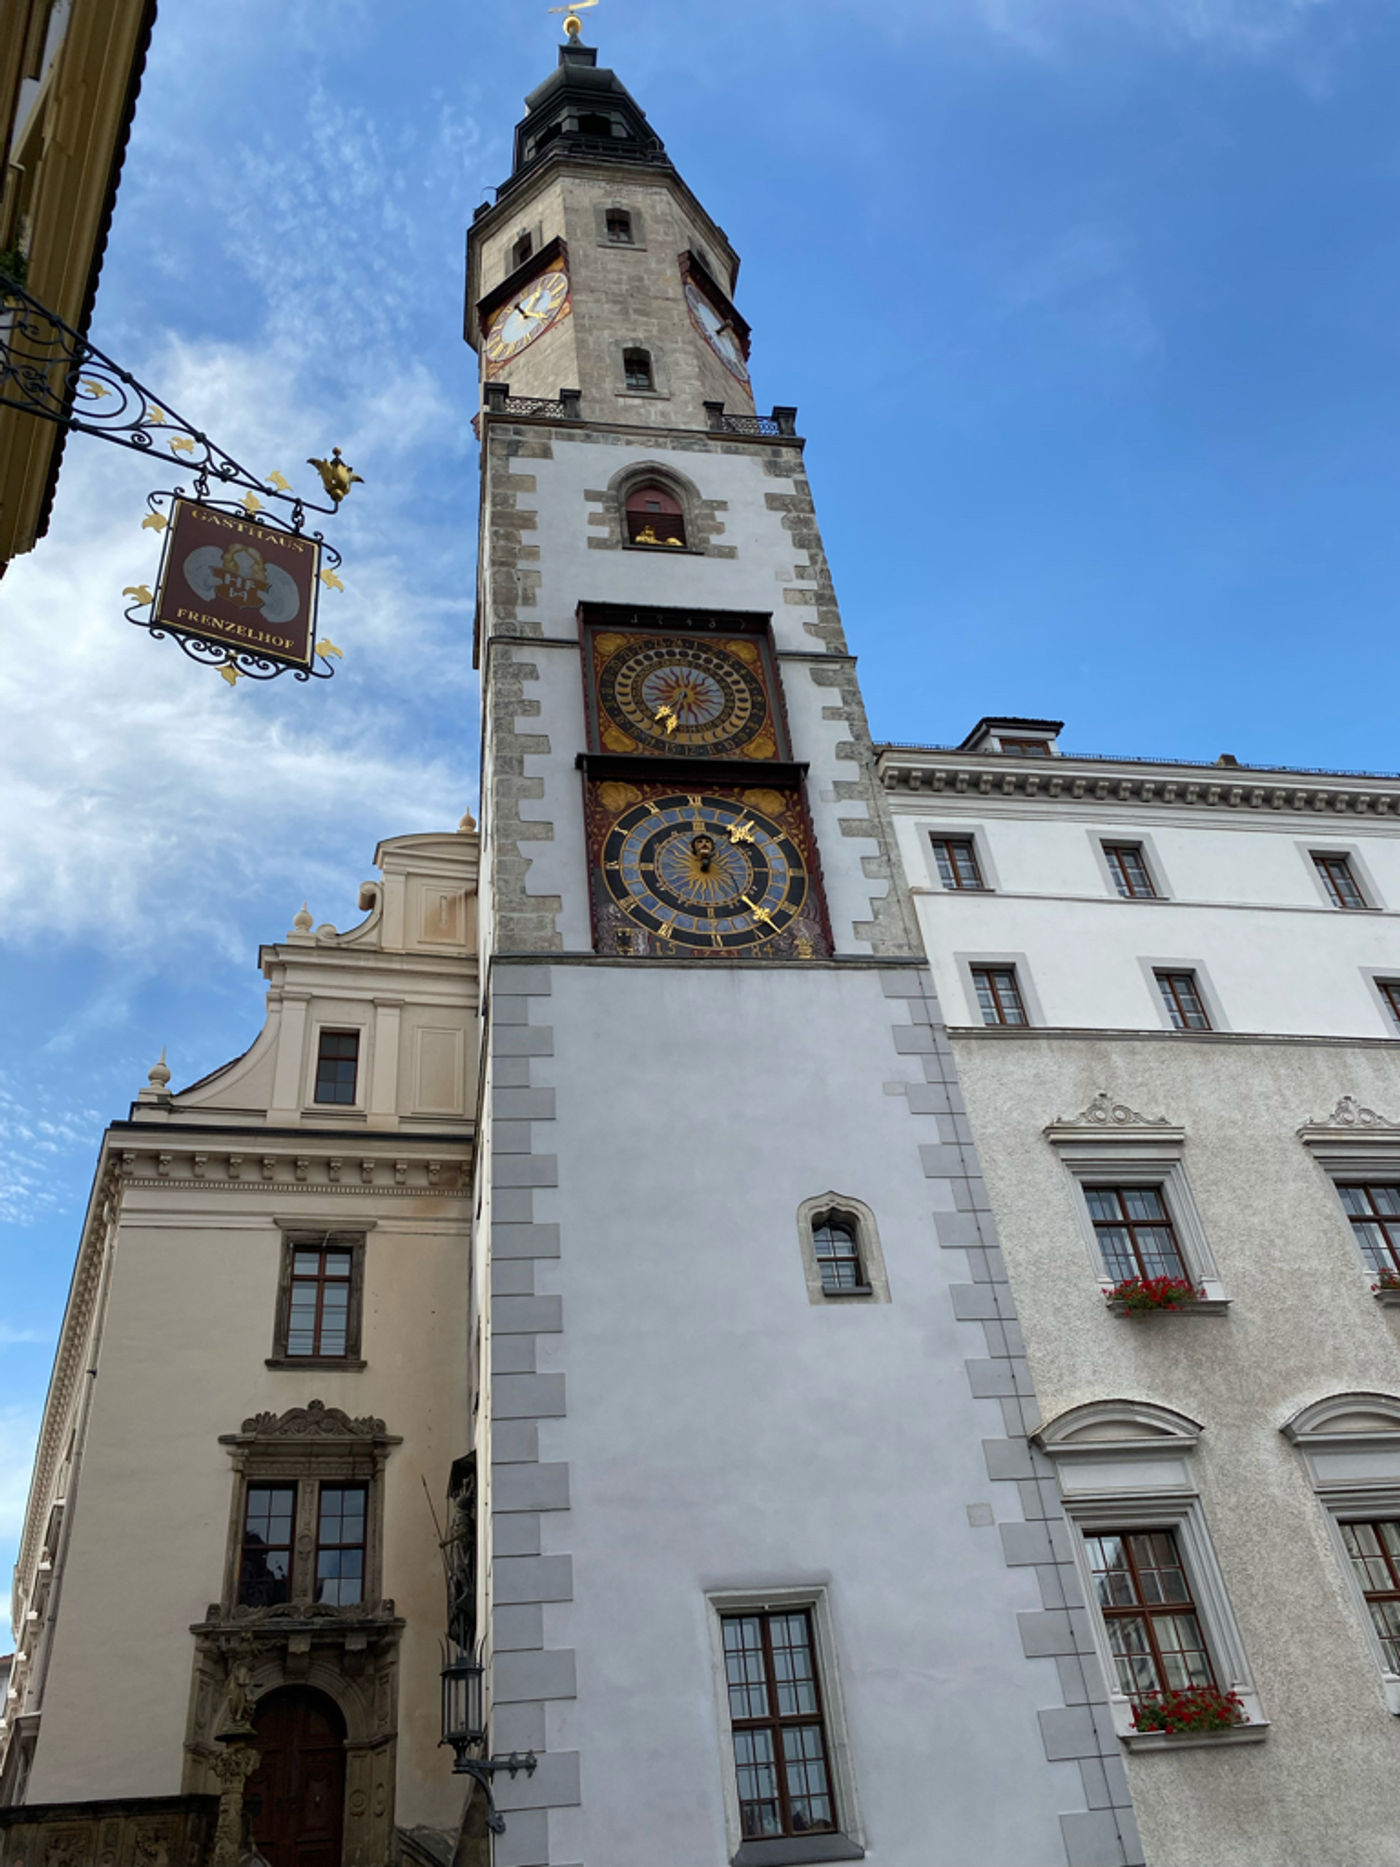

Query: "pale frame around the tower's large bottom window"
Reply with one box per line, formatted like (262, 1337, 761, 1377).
(706, 1583, 866, 1867)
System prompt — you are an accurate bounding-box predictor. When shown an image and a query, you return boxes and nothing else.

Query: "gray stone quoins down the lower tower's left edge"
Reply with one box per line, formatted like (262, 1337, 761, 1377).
(483, 960, 579, 1867)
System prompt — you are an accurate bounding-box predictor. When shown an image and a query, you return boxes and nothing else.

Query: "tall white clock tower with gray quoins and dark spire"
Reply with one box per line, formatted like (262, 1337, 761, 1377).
(466, 39, 1139, 1867)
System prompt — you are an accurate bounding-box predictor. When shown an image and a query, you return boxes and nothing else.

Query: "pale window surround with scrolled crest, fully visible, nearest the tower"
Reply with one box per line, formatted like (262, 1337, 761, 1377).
(1045, 1105, 1230, 1316)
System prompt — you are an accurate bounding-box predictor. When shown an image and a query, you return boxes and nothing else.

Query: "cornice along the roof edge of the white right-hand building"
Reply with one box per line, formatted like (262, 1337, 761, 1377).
(879, 752, 1400, 821)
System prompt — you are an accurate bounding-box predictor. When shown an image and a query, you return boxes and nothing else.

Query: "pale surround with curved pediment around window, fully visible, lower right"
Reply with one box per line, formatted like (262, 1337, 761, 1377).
(1036, 1400, 1269, 1751)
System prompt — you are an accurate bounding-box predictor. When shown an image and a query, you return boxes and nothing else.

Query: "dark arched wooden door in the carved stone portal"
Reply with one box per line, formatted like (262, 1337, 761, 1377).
(246, 1686, 345, 1867)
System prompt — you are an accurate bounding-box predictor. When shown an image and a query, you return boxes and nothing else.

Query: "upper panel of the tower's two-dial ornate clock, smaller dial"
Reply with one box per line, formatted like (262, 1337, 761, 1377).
(592, 631, 778, 758)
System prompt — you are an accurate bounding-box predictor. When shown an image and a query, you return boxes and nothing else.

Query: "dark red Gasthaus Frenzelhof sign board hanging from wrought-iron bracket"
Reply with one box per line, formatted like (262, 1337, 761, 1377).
(149, 498, 321, 668)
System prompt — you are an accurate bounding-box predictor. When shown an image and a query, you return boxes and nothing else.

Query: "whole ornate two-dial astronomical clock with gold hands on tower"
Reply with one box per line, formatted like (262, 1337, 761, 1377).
(582, 605, 831, 960)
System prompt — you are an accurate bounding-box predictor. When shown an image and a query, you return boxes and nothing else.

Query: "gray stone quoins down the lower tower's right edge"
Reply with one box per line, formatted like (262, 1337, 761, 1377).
(881, 967, 1142, 1867)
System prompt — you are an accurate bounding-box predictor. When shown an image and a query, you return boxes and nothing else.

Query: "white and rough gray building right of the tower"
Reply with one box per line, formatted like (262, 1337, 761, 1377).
(879, 721, 1400, 1867)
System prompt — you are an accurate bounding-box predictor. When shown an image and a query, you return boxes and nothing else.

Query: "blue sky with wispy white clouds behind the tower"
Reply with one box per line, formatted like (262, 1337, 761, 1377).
(0, 0, 1400, 1635)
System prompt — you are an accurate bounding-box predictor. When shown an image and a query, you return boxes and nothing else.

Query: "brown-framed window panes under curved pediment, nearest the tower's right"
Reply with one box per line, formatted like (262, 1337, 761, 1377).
(1085, 1529, 1215, 1703)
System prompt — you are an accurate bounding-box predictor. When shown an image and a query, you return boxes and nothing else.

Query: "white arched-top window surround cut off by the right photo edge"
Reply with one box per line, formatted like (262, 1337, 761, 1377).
(1281, 1393, 1400, 1718)
